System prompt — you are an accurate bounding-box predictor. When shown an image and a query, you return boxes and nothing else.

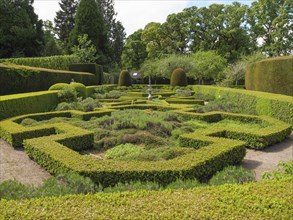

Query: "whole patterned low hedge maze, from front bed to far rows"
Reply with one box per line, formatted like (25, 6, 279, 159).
(0, 88, 292, 186)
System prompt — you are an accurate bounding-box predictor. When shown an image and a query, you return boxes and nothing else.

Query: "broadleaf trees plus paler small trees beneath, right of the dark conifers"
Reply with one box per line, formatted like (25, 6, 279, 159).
(121, 0, 293, 86)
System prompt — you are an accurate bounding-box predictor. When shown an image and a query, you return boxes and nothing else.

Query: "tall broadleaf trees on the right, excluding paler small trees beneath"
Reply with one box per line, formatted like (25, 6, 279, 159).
(122, 0, 293, 69)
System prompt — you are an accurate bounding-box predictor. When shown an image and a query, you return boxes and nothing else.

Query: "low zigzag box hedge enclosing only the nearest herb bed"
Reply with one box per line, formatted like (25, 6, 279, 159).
(0, 105, 291, 186)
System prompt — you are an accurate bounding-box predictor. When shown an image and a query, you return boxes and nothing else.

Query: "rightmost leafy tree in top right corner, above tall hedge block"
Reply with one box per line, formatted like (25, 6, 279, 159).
(248, 0, 293, 56)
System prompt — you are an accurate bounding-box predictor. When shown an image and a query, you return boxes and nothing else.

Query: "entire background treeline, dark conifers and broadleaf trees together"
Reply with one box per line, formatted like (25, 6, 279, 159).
(0, 0, 293, 86)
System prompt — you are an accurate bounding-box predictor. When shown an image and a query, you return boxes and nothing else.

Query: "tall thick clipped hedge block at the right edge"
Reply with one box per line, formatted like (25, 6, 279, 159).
(245, 56, 293, 96)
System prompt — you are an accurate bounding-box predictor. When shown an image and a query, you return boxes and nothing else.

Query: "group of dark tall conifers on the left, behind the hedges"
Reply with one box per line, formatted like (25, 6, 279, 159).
(0, 0, 125, 69)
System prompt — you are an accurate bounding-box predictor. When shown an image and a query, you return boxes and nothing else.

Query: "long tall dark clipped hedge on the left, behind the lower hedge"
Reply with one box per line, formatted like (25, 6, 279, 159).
(0, 64, 97, 95)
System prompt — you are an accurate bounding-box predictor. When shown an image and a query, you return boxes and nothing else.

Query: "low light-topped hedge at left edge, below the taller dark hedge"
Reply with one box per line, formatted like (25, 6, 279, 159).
(0, 91, 58, 120)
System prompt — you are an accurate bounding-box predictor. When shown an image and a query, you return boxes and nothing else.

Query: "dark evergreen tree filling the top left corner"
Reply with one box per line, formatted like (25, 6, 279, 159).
(0, 0, 44, 57)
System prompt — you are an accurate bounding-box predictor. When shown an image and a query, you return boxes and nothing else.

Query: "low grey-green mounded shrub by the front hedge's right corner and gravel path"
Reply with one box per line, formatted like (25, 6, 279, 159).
(209, 166, 255, 185)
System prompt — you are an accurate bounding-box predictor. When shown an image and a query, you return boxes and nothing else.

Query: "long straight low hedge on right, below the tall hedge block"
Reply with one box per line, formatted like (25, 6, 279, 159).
(192, 85, 293, 124)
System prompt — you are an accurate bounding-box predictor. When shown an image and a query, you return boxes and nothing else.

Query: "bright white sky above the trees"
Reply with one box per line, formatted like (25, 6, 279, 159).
(34, 0, 253, 36)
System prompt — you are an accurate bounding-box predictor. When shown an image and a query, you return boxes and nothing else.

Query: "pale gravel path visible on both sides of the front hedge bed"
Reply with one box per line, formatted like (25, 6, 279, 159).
(0, 133, 293, 185)
